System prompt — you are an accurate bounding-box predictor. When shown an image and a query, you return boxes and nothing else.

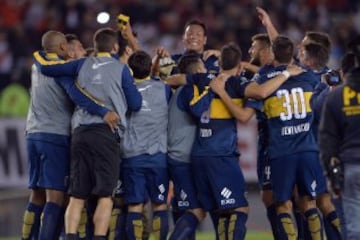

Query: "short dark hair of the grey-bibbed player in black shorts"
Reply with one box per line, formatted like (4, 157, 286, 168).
(94, 28, 118, 52)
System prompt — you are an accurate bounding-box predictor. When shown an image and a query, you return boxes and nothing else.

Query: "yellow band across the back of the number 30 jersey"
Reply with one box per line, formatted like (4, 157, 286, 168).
(264, 90, 312, 120)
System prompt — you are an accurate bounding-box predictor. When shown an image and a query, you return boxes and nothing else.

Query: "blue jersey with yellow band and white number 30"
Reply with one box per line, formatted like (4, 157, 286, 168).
(258, 65, 318, 158)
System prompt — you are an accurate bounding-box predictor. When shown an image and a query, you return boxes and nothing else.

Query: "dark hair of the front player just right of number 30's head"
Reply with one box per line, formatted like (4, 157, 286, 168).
(304, 42, 329, 68)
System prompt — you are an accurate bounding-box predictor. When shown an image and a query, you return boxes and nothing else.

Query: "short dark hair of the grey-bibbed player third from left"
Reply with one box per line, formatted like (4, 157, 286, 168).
(128, 50, 152, 79)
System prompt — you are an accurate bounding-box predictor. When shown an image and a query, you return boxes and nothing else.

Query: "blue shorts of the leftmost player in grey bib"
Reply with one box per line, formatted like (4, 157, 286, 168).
(26, 133, 70, 191)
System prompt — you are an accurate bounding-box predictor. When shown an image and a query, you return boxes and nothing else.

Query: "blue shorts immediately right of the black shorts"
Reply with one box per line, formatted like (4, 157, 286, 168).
(122, 167, 169, 204)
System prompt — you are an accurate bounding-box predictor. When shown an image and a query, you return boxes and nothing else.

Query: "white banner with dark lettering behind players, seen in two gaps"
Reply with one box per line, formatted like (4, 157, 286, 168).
(0, 119, 257, 187)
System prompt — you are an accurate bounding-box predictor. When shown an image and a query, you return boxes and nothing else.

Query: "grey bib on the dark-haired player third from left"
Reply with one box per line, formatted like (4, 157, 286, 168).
(121, 79, 168, 158)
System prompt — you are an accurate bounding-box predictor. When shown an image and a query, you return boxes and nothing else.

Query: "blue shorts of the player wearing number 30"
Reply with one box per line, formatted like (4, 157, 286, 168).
(270, 152, 321, 202)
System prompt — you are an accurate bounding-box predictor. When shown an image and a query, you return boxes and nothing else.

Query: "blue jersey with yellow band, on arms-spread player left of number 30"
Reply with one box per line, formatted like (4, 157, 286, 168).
(187, 71, 248, 156)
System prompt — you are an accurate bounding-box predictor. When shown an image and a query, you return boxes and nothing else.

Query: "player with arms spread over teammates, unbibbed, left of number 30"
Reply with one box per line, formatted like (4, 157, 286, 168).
(166, 44, 300, 239)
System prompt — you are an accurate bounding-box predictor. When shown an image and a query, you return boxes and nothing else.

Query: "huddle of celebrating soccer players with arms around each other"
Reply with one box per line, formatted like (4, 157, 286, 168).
(22, 5, 343, 240)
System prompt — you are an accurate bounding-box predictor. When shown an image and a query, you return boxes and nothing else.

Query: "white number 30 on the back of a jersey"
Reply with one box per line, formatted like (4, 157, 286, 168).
(276, 88, 306, 121)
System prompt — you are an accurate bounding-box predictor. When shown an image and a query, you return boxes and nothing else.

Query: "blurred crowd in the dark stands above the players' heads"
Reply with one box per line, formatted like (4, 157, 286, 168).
(0, 0, 360, 116)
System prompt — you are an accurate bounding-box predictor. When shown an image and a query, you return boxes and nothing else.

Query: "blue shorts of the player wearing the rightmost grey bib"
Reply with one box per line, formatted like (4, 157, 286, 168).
(168, 157, 201, 211)
